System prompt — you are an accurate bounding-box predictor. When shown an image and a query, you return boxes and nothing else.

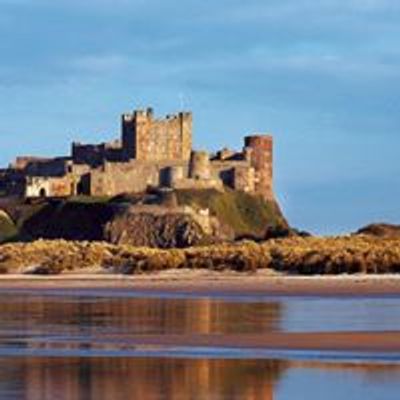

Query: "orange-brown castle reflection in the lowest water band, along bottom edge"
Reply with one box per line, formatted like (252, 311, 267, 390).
(0, 358, 284, 400)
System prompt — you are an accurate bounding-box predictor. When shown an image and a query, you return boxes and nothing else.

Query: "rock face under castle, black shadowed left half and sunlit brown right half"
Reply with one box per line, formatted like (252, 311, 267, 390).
(14, 201, 210, 248)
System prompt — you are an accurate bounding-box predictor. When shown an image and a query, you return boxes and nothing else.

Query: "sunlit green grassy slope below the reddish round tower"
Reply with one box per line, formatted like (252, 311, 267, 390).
(177, 190, 287, 237)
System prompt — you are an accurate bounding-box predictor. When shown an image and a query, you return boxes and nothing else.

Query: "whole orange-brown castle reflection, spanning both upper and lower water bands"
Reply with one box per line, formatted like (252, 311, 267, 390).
(0, 297, 285, 400)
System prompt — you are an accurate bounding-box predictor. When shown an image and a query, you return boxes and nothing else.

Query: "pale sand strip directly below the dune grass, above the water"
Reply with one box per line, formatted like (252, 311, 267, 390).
(0, 270, 400, 297)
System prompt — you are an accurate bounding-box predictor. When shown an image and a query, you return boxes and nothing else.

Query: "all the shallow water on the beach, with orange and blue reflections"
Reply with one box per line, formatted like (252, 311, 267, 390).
(0, 289, 400, 400)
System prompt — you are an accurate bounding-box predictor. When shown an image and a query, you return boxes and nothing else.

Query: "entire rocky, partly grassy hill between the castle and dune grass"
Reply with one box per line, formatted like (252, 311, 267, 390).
(0, 190, 287, 248)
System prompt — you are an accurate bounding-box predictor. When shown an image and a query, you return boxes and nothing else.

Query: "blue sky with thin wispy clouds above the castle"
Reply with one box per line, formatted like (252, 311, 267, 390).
(0, 0, 400, 234)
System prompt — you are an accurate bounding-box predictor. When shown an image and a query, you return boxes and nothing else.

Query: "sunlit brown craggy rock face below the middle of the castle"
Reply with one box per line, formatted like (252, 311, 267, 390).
(105, 212, 207, 249)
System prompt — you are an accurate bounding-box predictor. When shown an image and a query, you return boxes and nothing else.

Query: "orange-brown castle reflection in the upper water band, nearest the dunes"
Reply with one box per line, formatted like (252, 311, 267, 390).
(0, 296, 281, 335)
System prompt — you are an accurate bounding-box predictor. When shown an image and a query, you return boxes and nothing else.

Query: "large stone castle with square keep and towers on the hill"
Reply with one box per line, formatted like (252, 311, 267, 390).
(0, 108, 274, 200)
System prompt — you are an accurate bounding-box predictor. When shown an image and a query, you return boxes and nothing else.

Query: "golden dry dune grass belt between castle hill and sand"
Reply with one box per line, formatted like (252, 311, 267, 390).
(0, 235, 400, 275)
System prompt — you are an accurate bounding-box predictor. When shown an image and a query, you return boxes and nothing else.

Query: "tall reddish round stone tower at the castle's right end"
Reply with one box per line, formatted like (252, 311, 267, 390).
(245, 135, 274, 200)
